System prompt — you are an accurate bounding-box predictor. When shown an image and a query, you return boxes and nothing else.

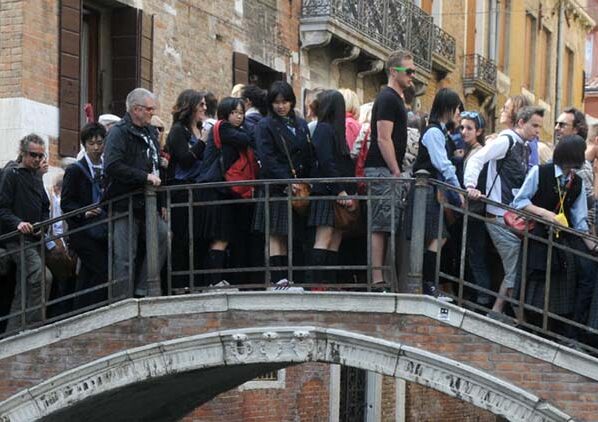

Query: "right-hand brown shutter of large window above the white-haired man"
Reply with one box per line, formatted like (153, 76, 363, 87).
(111, 7, 154, 116)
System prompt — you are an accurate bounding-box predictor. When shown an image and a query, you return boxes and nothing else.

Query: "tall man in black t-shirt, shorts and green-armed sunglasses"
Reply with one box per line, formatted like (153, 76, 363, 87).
(365, 48, 415, 290)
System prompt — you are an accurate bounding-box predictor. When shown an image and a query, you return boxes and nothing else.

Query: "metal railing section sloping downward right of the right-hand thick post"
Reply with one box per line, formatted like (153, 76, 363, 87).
(428, 173, 598, 354)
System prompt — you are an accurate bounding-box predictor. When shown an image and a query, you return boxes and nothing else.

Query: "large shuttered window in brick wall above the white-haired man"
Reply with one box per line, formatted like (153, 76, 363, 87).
(59, 0, 153, 157)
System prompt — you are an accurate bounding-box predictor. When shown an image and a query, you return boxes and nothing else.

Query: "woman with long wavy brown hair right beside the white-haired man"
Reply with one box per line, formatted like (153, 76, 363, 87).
(166, 89, 206, 288)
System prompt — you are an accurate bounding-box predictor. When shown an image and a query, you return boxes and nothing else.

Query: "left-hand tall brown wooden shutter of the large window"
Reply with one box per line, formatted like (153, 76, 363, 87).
(58, 0, 81, 157)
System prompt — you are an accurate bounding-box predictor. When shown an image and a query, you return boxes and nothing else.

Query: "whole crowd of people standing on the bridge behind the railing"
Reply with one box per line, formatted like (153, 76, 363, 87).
(0, 48, 598, 346)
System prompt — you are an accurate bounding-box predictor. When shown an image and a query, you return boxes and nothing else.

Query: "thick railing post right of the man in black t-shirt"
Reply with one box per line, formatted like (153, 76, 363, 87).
(401, 170, 430, 293)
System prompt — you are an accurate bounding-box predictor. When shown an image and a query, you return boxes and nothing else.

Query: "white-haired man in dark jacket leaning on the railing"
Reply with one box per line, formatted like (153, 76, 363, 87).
(104, 88, 168, 297)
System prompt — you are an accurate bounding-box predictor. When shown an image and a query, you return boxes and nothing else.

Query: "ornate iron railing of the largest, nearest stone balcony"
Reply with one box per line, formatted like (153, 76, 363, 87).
(302, 0, 434, 71)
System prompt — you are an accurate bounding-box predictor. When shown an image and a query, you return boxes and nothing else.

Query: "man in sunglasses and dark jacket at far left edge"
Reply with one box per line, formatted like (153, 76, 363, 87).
(0, 134, 51, 330)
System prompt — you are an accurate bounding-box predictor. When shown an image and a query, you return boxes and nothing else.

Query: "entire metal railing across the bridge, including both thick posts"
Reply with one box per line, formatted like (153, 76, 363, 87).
(0, 175, 598, 353)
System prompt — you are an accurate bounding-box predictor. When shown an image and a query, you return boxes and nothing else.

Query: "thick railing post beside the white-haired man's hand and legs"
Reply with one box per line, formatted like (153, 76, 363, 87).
(145, 187, 164, 296)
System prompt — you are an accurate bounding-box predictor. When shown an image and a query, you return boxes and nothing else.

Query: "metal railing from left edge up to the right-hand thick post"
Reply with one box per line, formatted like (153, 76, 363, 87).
(0, 178, 412, 335)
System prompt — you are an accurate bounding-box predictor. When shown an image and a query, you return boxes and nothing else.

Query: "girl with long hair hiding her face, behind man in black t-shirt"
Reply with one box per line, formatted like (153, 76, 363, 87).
(307, 90, 358, 283)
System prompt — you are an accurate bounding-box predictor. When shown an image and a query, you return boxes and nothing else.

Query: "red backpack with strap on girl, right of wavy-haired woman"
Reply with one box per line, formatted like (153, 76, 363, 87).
(212, 120, 258, 199)
